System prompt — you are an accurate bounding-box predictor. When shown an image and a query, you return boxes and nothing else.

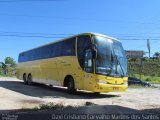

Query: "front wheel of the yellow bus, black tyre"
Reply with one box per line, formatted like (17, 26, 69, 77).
(67, 77, 76, 94)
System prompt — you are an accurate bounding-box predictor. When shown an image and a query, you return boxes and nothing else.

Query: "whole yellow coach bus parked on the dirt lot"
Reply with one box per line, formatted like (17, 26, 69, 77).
(17, 33, 128, 93)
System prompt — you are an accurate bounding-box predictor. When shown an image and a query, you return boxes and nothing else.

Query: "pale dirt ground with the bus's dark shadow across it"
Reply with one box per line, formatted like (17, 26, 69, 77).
(0, 77, 160, 112)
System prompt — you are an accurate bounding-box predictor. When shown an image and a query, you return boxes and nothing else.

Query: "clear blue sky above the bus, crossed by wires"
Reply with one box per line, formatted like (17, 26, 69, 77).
(0, 0, 160, 62)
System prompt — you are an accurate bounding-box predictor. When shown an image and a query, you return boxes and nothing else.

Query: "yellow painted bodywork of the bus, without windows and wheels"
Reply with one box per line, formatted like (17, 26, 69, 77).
(17, 33, 128, 92)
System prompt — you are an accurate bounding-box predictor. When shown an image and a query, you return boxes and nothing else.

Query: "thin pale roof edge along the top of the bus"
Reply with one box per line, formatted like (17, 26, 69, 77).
(20, 32, 119, 54)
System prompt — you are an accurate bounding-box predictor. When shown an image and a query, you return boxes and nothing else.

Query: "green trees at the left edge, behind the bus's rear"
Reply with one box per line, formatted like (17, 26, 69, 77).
(0, 57, 16, 76)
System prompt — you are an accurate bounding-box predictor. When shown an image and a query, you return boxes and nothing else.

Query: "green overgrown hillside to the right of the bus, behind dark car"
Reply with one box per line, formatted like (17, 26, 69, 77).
(128, 57, 160, 83)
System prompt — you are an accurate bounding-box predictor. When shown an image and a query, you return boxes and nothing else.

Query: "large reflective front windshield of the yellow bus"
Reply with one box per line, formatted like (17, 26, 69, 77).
(94, 36, 127, 76)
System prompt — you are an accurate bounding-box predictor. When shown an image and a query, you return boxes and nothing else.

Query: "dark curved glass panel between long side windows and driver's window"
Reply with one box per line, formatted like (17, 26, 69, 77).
(77, 35, 92, 70)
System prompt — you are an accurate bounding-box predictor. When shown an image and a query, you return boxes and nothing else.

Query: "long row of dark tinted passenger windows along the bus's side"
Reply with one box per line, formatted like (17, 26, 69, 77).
(18, 38, 75, 62)
